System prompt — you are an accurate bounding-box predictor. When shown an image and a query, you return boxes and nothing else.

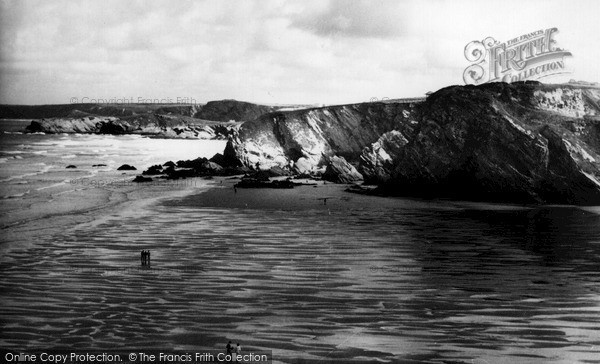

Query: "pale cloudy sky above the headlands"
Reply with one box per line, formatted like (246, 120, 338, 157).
(0, 0, 600, 104)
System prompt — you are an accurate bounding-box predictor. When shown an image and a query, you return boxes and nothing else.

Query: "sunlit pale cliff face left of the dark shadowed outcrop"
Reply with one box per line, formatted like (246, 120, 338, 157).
(228, 103, 415, 171)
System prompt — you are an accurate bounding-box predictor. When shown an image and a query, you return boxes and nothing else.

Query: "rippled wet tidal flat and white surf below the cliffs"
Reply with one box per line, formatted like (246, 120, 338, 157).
(0, 120, 600, 363)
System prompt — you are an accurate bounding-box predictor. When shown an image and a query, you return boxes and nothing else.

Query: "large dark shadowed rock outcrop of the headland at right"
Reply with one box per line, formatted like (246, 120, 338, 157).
(360, 83, 600, 204)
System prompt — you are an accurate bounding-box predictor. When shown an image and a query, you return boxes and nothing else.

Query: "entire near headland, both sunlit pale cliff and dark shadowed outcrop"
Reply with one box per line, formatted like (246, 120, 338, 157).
(228, 83, 600, 204)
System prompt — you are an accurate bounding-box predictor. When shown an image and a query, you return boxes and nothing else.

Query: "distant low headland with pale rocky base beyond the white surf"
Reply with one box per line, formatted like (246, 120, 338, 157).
(7, 100, 278, 139)
